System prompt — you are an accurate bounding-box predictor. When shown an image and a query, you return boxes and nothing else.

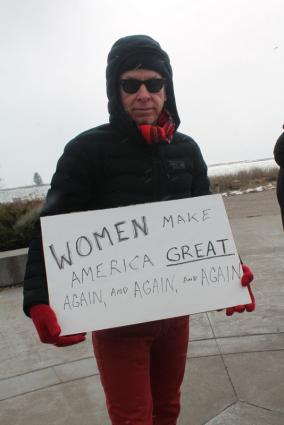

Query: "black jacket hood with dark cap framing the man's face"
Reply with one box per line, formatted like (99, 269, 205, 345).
(106, 35, 180, 132)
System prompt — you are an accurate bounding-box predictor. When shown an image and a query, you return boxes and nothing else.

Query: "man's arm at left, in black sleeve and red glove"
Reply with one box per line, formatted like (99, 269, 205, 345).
(24, 137, 101, 346)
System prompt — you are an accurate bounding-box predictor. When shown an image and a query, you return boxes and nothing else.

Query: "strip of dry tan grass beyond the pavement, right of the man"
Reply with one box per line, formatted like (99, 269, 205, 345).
(210, 167, 278, 193)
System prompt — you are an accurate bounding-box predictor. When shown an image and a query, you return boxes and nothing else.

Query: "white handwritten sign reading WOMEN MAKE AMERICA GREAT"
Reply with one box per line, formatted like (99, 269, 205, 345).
(41, 195, 250, 335)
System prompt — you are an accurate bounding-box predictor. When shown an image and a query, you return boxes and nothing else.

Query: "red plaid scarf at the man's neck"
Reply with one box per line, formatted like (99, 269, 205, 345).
(138, 111, 175, 145)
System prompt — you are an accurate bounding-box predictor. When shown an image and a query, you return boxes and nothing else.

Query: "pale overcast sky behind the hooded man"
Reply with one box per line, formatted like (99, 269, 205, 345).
(0, 0, 284, 188)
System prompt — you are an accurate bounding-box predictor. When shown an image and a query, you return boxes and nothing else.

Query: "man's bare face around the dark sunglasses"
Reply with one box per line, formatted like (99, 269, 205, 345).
(120, 69, 166, 124)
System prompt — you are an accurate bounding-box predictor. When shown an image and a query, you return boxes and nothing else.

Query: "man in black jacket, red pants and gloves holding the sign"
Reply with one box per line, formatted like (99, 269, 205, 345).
(24, 35, 254, 425)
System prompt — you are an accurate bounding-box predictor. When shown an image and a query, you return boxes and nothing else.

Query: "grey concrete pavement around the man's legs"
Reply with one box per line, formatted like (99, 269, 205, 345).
(0, 190, 284, 425)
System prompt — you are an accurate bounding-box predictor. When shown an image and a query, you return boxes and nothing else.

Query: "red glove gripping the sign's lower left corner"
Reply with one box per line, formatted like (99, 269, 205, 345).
(30, 304, 86, 347)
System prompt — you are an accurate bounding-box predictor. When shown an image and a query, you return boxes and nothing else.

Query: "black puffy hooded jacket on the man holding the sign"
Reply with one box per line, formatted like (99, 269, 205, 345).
(24, 36, 210, 315)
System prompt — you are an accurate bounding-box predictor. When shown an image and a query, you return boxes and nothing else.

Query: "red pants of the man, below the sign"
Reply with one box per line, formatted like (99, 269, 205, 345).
(93, 316, 189, 425)
